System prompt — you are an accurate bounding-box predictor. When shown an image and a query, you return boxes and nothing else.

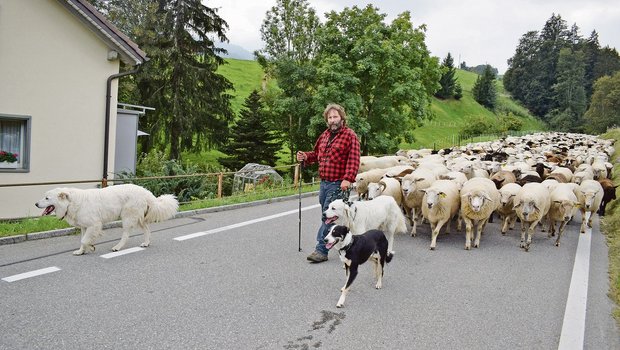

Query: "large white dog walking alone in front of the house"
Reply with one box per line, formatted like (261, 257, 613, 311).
(35, 184, 179, 255)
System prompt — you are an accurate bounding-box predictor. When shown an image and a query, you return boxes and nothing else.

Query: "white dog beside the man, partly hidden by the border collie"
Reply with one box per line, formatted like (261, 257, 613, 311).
(324, 196, 407, 254)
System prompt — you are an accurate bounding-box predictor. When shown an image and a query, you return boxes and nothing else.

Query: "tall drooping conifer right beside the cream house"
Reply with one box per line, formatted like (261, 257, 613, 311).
(95, 0, 233, 159)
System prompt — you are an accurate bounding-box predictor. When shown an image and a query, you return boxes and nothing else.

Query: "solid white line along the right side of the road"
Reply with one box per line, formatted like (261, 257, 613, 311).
(558, 229, 592, 350)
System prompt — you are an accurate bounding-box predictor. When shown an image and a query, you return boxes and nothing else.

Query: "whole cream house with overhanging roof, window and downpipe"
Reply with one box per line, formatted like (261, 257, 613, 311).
(0, 0, 147, 219)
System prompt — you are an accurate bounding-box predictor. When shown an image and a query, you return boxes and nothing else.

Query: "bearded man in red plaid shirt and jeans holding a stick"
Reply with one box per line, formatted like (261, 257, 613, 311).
(297, 104, 360, 263)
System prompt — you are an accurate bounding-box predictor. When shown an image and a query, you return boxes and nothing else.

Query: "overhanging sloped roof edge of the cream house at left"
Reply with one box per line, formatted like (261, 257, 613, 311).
(58, 0, 148, 66)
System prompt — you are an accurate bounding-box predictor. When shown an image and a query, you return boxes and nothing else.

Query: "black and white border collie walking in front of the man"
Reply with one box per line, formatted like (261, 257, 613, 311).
(324, 225, 393, 307)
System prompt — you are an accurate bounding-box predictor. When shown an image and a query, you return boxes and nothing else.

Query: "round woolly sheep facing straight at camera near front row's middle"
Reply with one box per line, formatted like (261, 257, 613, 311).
(461, 177, 500, 250)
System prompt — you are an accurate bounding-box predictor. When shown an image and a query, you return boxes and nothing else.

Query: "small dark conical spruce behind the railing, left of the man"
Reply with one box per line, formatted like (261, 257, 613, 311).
(218, 90, 280, 170)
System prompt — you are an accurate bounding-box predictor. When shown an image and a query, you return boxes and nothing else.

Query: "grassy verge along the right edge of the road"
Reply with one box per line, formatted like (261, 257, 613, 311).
(601, 128, 620, 324)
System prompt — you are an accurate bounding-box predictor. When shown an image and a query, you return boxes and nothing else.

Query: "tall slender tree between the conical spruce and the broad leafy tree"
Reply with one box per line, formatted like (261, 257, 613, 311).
(256, 0, 320, 161)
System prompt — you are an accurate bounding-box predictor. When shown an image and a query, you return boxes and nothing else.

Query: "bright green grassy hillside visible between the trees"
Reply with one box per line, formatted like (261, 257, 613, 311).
(219, 59, 544, 152)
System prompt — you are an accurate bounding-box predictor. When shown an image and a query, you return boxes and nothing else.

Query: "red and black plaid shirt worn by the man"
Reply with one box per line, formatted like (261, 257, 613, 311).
(305, 126, 360, 183)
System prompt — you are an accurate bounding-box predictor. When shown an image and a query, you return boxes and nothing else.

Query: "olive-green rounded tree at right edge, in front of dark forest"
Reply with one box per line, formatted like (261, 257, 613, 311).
(584, 71, 620, 134)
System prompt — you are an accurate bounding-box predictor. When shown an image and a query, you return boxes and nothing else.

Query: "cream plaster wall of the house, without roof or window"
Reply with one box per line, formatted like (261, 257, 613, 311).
(0, 0, 119, 219)
